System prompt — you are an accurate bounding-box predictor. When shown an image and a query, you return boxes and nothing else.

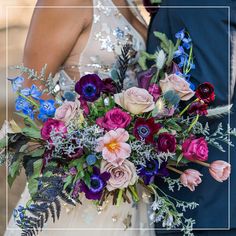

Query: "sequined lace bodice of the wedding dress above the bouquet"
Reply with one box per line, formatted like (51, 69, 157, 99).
(57, 0, 145, 90)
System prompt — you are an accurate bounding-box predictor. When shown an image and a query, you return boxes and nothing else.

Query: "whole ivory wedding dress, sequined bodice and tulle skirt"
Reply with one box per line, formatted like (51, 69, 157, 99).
(5, 0, 154, 236)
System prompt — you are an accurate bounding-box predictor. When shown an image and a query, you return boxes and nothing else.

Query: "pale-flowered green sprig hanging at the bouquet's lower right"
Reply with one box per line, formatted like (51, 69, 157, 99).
(150, 186, 198, 236)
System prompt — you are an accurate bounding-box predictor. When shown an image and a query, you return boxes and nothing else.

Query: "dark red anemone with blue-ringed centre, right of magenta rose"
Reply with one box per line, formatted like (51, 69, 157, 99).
(133, 118, 161, 143)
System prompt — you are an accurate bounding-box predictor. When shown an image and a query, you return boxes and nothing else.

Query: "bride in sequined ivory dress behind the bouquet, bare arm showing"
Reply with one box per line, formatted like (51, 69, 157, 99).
(5, 0, 154, 236)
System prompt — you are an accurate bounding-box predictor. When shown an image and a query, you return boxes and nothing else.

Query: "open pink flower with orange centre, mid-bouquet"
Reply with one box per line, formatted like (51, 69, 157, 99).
(96, 128, 131, 166)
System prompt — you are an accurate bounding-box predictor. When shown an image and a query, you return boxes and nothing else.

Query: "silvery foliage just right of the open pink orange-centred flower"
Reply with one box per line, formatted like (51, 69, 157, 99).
(129, 140, 175, 166)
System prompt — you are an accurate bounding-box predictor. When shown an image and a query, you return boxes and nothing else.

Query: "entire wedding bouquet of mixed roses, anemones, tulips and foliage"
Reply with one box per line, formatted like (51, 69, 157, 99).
(0, 30, 236, 235)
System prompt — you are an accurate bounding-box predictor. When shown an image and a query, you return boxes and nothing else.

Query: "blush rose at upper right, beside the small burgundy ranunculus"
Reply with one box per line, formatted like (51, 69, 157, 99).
(159, 74, 195, 101)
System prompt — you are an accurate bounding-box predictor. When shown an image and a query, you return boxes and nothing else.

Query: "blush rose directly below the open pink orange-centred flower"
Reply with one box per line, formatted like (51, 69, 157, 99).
(101, 160, 138, 191)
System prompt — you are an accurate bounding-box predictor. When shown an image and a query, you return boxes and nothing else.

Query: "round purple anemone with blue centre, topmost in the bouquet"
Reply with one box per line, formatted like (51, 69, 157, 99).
(75, 74, 103, 102)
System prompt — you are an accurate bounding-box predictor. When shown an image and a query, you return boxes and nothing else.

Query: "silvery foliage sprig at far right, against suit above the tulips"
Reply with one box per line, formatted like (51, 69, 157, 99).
(192, 122, 236, 152)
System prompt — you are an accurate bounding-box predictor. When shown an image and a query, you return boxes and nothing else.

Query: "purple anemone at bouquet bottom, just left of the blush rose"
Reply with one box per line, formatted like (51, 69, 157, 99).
(80, 167, 110, 200)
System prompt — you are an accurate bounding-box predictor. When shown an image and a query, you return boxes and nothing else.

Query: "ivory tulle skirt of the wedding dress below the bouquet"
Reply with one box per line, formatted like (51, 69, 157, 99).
(4, 188, 155, 236)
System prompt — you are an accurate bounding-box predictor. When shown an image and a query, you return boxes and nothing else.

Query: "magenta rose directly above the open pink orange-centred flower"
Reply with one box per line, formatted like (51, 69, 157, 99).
(96, 108, 131, 130)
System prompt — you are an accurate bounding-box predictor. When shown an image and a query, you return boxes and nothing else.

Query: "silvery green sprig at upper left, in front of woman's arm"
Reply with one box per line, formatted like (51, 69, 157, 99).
(13, 65, 56, 94)
